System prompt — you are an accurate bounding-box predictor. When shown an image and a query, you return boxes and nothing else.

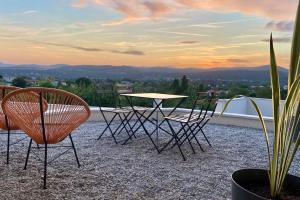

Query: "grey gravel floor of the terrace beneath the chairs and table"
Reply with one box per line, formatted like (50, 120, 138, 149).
(0, 123, 299, 200)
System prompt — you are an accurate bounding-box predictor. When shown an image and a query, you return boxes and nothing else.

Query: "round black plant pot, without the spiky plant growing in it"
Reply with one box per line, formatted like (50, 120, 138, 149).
(231, 169, 300, 200)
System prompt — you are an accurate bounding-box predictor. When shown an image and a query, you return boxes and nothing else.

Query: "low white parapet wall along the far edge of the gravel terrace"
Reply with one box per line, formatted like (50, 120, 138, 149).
(89, 97, 278, 131)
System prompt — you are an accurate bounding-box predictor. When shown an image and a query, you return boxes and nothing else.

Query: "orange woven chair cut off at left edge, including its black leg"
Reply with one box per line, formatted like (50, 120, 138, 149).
(0, 85, 20, 164)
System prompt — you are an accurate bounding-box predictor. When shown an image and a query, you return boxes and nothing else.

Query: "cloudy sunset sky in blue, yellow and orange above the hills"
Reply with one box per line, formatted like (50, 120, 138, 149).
(0, 0, 298, 67)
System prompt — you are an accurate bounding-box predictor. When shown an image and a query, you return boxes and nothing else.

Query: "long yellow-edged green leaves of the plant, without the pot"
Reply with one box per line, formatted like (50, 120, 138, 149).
(221, 1, 300, 199)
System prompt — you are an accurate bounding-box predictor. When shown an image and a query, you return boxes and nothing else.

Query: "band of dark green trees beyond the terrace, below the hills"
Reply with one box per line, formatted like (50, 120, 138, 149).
(5, 75, 285, 108)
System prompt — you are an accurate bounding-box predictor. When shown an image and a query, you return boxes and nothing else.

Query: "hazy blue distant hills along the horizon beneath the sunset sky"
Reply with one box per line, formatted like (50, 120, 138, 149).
(0, 63, 288, 83)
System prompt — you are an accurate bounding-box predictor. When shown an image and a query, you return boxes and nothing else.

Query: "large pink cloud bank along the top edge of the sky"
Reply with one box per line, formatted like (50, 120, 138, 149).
(72, 0, 298, 22)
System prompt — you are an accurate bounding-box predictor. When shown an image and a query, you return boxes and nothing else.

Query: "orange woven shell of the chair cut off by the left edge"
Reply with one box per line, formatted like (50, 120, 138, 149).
(0, 85, 20, 130)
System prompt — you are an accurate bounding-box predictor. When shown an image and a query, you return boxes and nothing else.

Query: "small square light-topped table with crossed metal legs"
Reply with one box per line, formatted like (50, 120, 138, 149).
(121, 93, 188, 153)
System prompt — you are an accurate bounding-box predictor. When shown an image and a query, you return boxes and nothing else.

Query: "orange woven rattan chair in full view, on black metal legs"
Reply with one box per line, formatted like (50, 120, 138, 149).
(2, 88, 91, 188)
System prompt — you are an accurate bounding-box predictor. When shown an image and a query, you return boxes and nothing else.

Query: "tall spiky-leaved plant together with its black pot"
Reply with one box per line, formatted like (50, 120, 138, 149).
(222, 2, 300, 200)
